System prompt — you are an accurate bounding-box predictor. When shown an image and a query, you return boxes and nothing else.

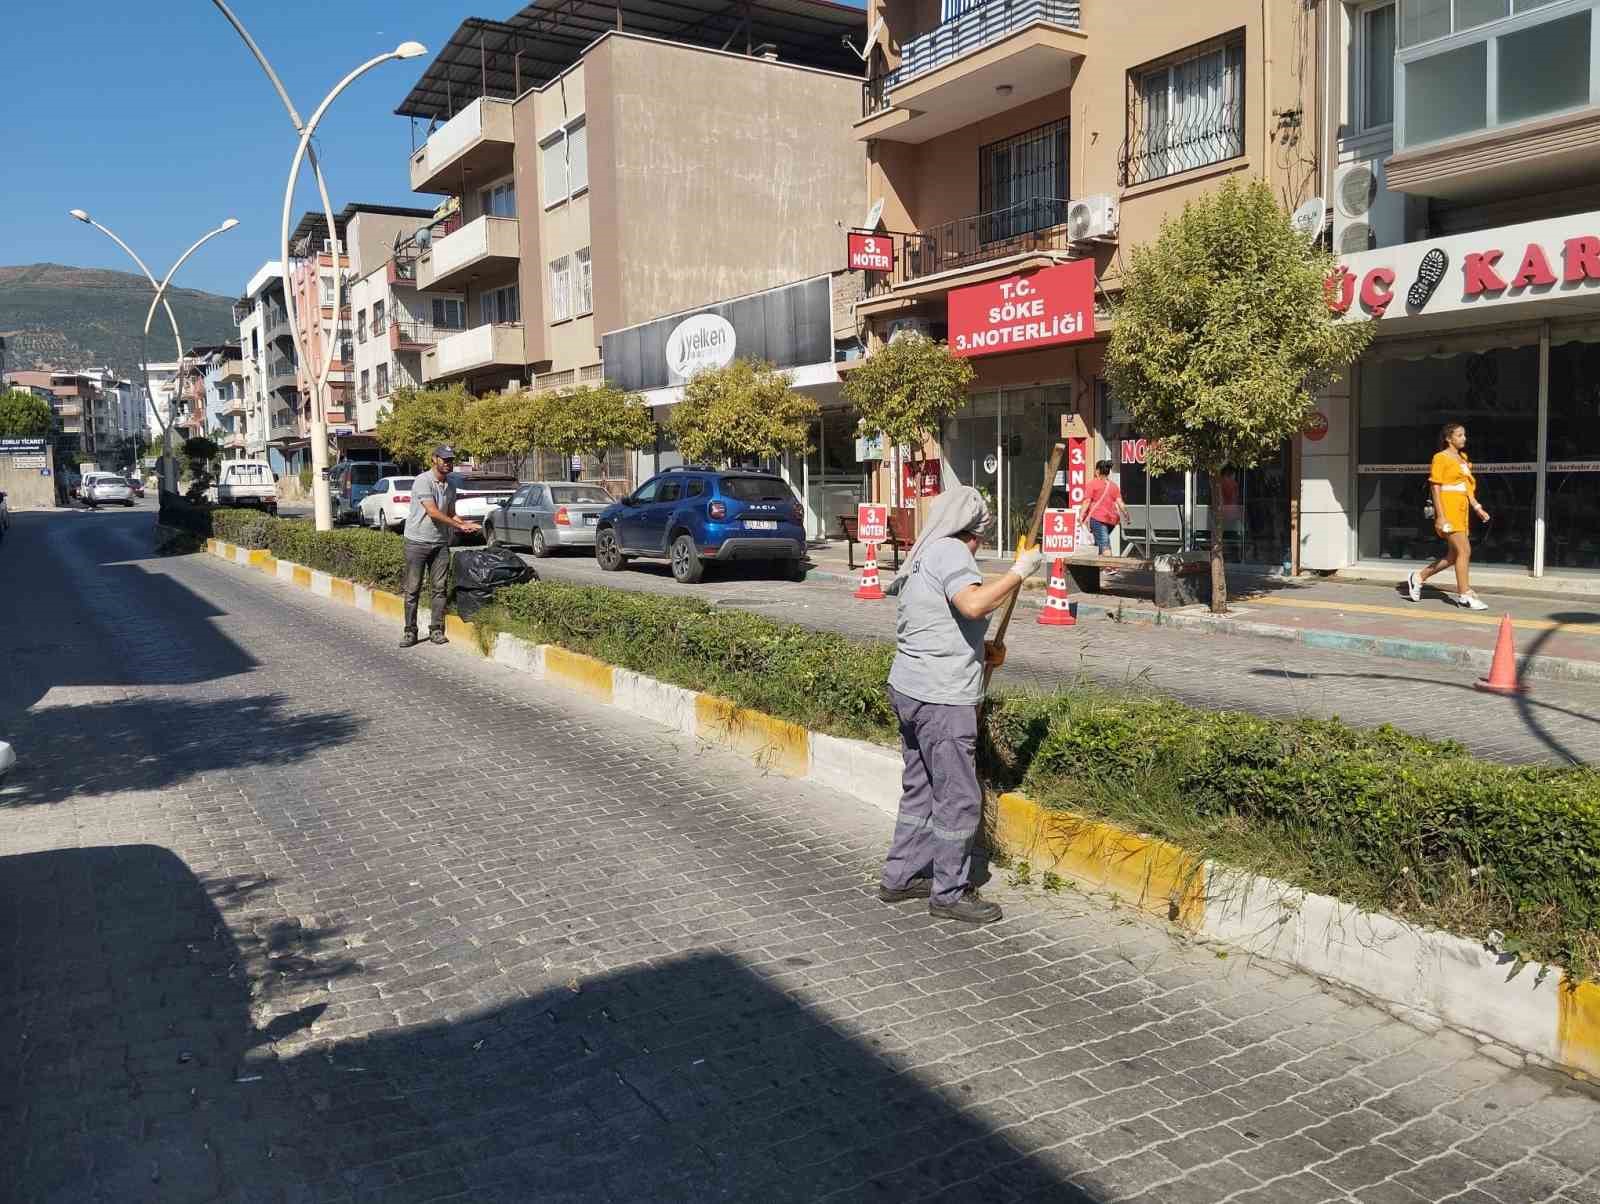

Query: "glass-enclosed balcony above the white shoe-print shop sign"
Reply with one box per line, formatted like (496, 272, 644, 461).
(1384, 0, 1600, 200)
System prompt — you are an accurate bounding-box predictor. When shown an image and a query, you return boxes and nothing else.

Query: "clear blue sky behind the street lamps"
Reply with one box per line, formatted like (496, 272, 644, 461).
(0, 0, 505, 296)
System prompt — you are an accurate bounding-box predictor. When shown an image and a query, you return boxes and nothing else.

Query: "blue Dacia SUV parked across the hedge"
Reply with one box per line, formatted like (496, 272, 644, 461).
(595, 468, 805, 584)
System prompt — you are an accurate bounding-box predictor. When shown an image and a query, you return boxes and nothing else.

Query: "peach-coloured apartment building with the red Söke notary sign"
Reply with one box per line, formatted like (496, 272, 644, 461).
(835, 0, 1338, 565)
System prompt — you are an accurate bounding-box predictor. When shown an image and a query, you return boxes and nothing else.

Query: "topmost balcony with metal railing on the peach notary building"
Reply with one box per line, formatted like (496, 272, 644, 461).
(856, 0, 1088, 142)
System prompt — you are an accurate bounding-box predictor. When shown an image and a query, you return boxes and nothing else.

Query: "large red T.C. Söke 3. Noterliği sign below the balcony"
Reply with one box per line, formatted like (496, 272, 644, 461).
(949, 259, 1094, 355)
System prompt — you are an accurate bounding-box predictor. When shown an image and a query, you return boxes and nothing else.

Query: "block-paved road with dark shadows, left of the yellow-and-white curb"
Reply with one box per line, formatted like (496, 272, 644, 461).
(0, 514, 1600, 1204)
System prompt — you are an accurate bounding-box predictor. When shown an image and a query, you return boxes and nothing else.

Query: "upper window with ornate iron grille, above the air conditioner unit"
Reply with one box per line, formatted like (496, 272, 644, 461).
(1123, 32, 1245, 184)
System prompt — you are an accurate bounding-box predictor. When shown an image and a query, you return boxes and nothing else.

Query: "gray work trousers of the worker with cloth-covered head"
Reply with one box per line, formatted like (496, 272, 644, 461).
(883, 685, 984, 903)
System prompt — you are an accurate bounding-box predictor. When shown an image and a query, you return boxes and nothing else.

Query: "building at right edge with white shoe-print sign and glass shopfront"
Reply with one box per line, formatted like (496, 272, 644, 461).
(1302, 0, 1600, 580)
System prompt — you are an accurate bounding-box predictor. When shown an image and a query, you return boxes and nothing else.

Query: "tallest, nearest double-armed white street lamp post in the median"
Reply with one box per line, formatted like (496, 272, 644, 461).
(211, 0, 427, 532)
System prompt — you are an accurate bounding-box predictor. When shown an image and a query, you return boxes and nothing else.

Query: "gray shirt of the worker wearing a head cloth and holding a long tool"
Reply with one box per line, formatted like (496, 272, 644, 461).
(890, 538, 989, 706)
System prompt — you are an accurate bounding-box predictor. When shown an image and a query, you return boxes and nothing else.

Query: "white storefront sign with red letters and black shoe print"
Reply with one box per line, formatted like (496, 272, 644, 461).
(1328, 213, 1600, 322)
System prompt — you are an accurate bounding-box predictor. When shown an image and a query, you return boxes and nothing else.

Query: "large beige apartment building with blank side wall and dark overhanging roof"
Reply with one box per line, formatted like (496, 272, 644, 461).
(397, 0, 866, 400)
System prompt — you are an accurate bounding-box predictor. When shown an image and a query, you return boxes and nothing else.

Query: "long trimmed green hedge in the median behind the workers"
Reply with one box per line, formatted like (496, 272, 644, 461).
(200, 511, 1600, 969)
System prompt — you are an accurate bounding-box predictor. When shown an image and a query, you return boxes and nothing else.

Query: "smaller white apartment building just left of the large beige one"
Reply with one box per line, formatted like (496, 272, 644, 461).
(350, 224, 467, 434)
